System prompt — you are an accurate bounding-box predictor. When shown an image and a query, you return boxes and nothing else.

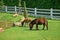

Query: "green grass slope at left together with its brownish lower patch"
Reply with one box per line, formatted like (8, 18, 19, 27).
(0, 13, 23, 29)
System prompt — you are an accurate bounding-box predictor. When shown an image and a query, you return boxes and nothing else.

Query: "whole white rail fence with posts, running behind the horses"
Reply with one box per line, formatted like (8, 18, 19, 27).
(0, 6, 60, 19)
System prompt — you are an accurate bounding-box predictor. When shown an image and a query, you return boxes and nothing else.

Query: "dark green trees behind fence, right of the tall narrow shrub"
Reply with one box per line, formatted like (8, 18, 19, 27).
(22, 0, 60, 9)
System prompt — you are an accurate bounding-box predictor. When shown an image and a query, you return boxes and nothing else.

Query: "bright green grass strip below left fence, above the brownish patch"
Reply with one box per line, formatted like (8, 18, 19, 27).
(0, 13, 22, 21)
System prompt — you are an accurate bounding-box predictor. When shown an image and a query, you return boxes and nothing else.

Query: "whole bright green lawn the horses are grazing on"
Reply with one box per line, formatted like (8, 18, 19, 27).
(0, 13, 60, 40)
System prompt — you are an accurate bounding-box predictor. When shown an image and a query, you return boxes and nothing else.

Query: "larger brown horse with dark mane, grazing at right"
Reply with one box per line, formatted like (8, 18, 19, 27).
(29, 18, 48, 30)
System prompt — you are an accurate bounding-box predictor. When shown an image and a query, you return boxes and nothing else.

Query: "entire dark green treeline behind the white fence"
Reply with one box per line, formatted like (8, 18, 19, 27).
(0, 0, 60, 9)
